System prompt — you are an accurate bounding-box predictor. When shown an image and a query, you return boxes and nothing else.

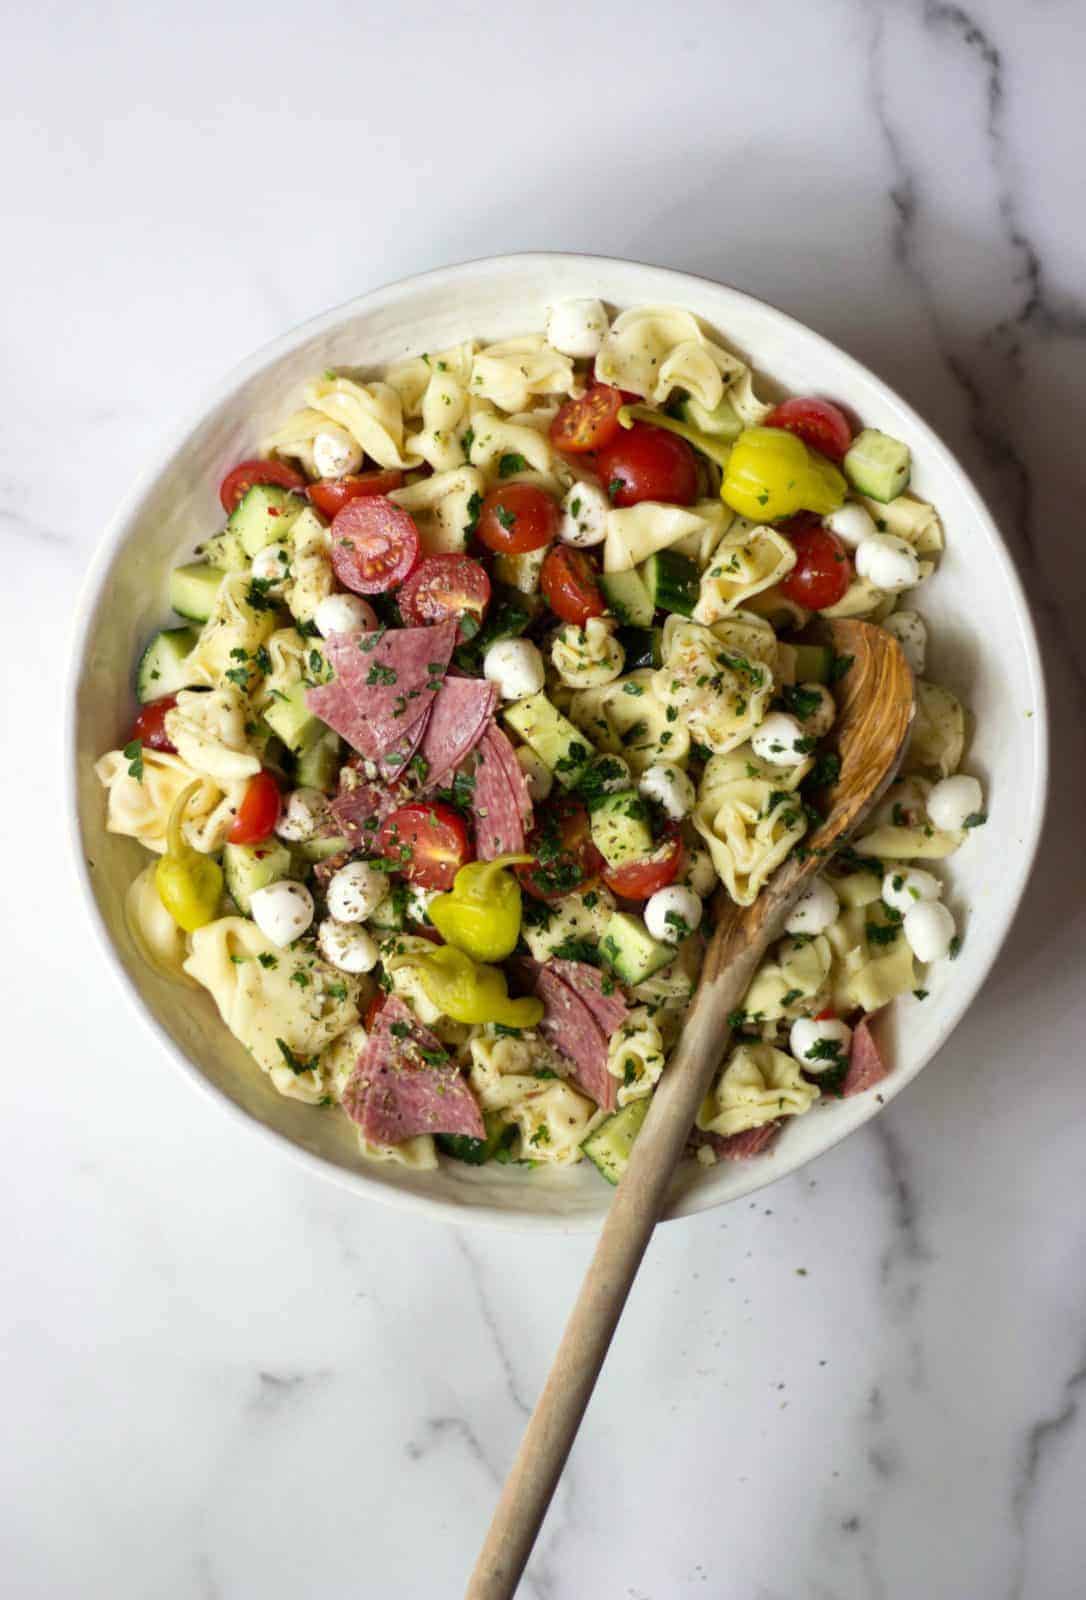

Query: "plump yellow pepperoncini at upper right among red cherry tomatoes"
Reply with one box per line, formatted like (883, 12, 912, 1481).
(720, 427, 844, 522)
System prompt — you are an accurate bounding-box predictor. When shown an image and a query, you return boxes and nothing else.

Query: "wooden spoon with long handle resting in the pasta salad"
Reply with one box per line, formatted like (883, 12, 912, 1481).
(465, 621, 913, 1600)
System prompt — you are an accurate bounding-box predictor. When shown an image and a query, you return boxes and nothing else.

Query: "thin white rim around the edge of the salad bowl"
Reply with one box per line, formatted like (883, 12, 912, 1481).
(62, 250, 1049, 1234)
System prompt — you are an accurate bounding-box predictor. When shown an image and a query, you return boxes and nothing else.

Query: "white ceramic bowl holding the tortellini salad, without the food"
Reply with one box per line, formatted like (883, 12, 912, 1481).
(69, 254, 1048, 1229)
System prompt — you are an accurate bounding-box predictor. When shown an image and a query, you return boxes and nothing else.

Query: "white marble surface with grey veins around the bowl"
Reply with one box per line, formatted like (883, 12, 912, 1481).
(0, 0, 1086, 1600)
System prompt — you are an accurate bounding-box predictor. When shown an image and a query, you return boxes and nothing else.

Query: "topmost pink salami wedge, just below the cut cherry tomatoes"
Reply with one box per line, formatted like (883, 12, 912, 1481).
(305, 619, 457, 762)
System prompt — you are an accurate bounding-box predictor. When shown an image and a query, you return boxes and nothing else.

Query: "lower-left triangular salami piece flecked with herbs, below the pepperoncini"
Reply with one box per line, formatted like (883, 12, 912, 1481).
(342, 995, 486, 1144)
